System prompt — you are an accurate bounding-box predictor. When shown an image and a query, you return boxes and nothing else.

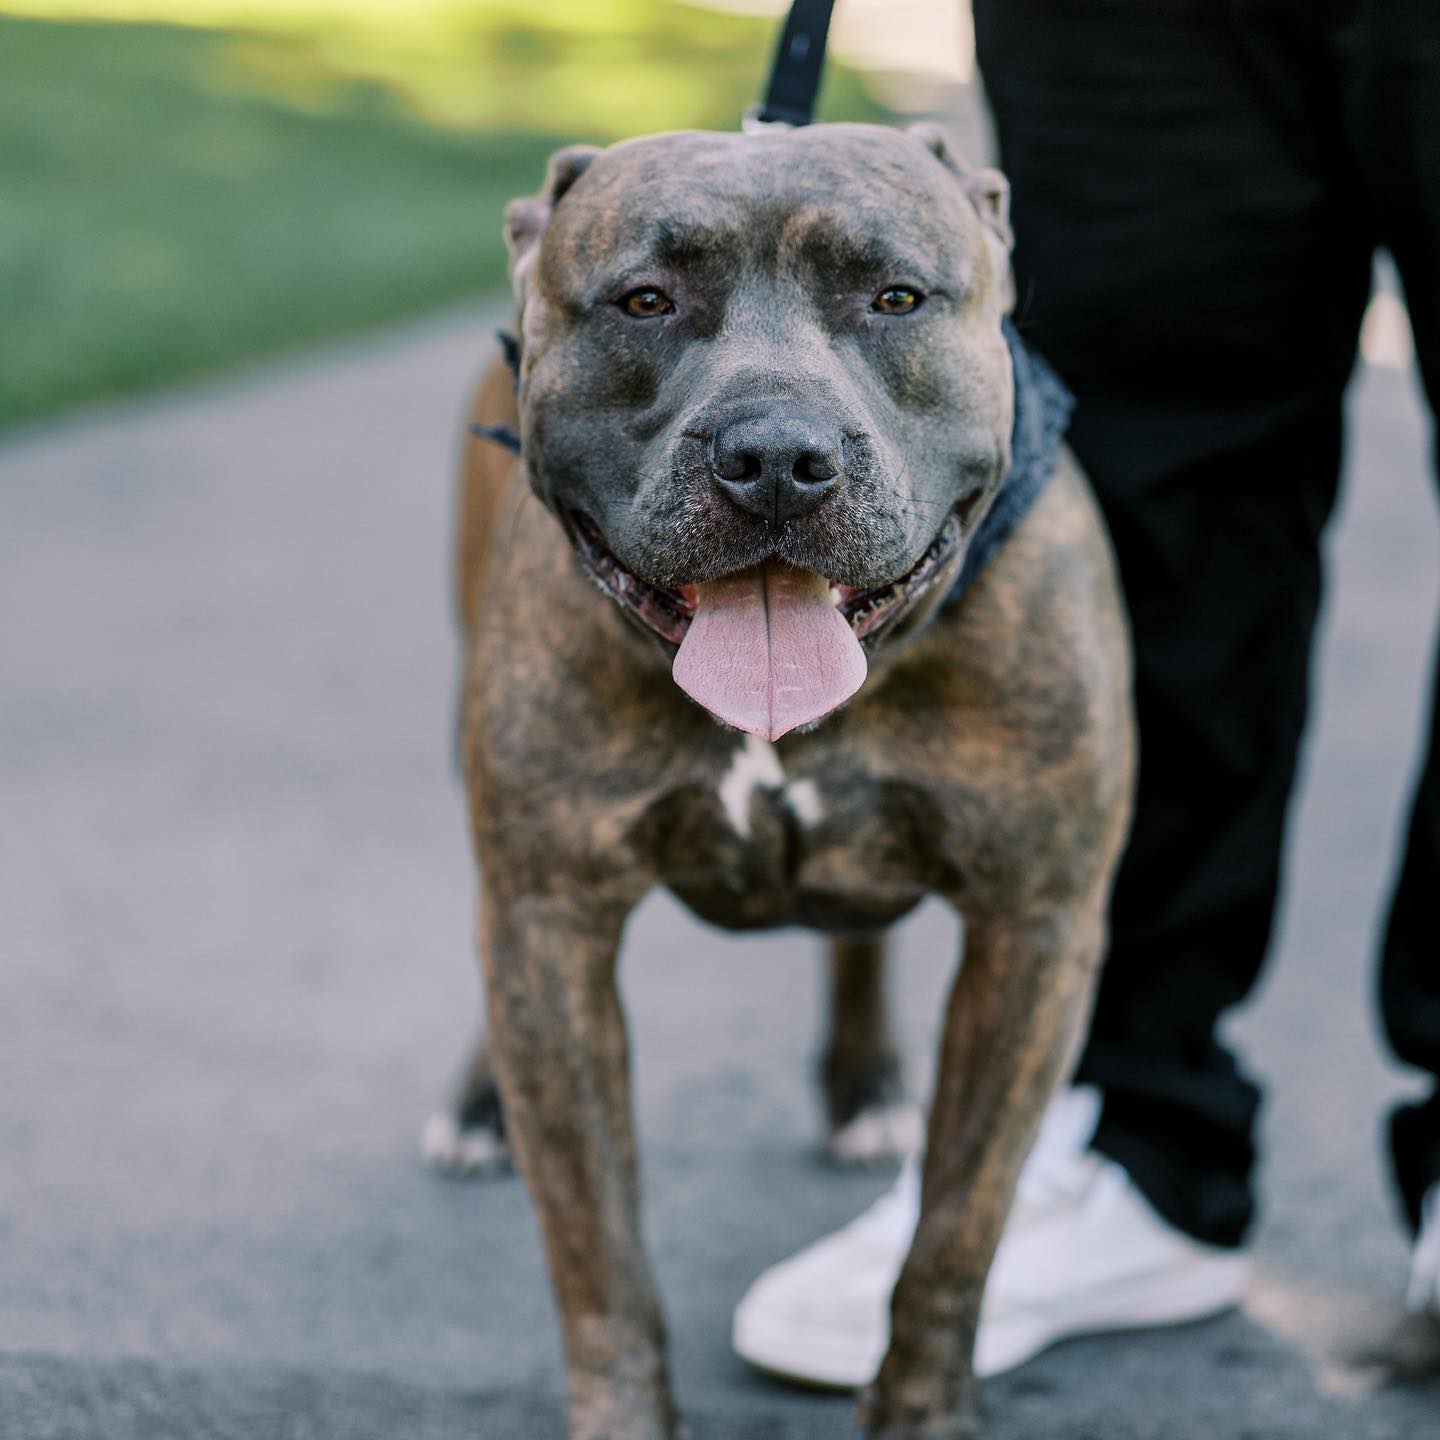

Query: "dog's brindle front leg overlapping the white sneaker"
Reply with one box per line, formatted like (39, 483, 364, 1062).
(861, 903, 1103, 1440)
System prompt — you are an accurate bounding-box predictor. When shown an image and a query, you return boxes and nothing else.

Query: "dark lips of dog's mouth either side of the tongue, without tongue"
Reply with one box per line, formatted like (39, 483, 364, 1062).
(564, 510, 960, 645)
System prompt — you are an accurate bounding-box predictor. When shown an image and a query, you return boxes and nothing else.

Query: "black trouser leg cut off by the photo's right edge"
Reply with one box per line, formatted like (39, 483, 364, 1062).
(1335, 0, 1440, 1227)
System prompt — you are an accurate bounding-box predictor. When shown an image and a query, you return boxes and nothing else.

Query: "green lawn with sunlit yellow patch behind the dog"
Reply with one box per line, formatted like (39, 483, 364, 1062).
(0, 8, 876, 425)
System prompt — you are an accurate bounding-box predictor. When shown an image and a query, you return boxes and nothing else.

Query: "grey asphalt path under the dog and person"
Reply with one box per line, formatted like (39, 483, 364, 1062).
(0, 298, 1440, 1440)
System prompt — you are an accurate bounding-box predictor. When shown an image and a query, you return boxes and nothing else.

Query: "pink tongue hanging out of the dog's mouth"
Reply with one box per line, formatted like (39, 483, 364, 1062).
(674, 562, 865, 740)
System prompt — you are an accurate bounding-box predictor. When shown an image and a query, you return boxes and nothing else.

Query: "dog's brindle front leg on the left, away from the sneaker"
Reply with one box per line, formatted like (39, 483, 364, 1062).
(481, 896, 677, 1440)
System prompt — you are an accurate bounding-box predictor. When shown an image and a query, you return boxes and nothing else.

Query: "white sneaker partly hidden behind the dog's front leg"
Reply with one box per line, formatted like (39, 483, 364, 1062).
(733, 1087, 1249, 1390)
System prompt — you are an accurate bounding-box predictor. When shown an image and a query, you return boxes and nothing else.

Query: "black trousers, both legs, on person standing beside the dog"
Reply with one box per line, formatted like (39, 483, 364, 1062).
(975, 0, 1440, 1244)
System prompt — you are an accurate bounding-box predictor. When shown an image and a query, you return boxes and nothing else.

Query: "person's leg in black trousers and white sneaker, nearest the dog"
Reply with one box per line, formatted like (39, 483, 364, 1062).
(734, 0, 1371, 1384)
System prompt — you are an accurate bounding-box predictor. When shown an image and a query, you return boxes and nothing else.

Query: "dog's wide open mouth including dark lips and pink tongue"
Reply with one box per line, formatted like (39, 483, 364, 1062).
(566, 511, 962, 740)
